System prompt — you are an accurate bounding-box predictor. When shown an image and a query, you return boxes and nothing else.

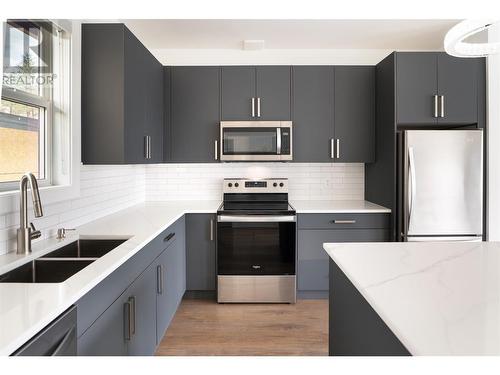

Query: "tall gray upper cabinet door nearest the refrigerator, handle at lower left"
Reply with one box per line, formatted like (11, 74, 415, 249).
(334, 66, 375, 163)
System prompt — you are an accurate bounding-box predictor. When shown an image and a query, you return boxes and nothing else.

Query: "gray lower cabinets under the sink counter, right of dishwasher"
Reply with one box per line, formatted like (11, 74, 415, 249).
(77, 217, 186, 356)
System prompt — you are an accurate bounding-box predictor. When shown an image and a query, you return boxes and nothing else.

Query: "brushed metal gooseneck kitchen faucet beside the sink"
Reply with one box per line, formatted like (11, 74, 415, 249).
(17, 172, 43, 254)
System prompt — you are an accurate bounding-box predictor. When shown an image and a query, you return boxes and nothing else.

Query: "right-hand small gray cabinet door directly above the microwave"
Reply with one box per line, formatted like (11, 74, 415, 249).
(256, 66, 291, 121)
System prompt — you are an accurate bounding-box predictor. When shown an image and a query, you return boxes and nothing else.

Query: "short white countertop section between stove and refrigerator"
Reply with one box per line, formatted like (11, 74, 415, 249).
(290, 200, 391, 214)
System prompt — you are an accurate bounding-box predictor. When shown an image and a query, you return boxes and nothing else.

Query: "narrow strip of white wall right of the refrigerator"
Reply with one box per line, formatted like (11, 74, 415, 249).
(488, 24, 500, 241)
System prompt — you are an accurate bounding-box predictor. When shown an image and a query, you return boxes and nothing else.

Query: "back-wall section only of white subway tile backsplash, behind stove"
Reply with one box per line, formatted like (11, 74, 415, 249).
(146, 163, 364, 201)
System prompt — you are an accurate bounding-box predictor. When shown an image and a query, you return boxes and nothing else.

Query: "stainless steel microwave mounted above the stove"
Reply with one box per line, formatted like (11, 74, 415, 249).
(220, 121, 293, 161)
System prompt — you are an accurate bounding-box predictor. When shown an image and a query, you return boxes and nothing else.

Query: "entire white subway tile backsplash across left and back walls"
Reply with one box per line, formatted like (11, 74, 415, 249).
(0, 163, 364, 254)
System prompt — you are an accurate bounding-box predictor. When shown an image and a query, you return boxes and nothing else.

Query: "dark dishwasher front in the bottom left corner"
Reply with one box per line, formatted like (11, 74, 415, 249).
(12, 306, 77, 356)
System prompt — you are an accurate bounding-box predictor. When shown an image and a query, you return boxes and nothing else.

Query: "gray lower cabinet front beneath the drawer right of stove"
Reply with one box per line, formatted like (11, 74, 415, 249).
(297, 229, 389, 291)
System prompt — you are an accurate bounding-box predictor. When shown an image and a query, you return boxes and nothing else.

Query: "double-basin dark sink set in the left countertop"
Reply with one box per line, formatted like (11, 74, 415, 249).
(0, 239, 126, 283)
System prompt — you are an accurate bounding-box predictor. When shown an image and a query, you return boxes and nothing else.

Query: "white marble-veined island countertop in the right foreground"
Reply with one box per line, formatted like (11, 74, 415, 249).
(324, 242, 500, 355)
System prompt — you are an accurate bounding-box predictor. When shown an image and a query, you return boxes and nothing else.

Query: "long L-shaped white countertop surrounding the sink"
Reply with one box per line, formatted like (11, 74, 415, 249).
(0, 201, 220, 355)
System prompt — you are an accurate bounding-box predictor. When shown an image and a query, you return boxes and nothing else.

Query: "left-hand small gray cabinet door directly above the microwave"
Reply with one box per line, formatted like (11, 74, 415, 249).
(222, 66, 257, 121)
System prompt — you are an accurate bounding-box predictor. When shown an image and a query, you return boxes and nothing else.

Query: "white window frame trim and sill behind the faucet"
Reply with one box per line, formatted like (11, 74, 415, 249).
(0, 20, 81, 215)
